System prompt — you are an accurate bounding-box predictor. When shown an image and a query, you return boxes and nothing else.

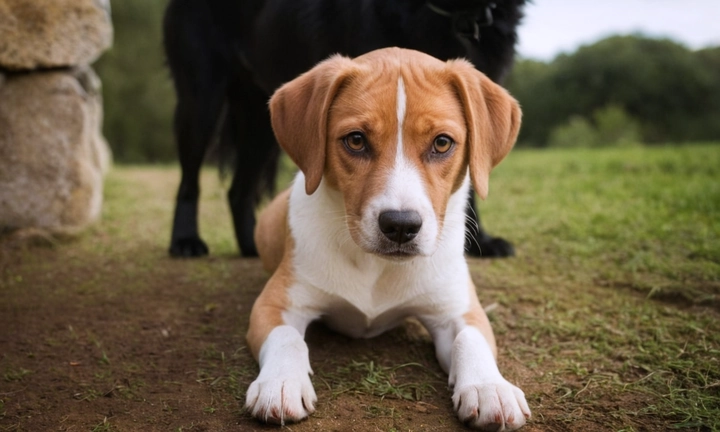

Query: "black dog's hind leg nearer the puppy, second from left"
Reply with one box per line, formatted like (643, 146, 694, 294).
(223, 84, 280, 257)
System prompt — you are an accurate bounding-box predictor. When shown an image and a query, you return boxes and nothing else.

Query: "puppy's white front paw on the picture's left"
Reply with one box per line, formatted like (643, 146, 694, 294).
(245, 374, 317, 425)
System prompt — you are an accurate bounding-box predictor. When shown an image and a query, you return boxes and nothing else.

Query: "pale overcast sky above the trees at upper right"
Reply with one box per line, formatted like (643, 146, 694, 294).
(518, 0, 720, 60)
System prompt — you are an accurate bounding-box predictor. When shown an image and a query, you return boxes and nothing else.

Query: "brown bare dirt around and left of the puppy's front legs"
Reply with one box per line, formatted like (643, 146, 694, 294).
(0, 247, 660, 431)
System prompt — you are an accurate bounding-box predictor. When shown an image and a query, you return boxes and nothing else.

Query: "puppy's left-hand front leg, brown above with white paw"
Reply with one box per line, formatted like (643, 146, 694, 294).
(245, 279, 317, 424)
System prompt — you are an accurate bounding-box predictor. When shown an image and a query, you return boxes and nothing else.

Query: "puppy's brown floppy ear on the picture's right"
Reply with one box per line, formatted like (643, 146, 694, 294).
(448, 60, 522, 199)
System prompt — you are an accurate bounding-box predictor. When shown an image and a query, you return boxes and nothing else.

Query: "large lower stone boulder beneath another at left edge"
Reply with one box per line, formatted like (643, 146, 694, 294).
(0, 67, 111, 233)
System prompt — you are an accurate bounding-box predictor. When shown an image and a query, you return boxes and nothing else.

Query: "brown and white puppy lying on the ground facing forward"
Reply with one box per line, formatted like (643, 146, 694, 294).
(246, 48, 530, 430)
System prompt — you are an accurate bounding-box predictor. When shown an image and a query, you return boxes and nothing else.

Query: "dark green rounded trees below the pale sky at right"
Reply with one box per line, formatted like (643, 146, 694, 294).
(508, 35, 720, 146)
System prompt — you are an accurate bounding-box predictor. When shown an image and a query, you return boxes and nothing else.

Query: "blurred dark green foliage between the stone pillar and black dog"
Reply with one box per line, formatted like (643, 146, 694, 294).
(95, 0, 176, 163)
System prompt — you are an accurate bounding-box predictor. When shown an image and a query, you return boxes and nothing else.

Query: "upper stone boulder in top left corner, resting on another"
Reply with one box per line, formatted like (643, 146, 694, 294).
(0, 0, 113, 70)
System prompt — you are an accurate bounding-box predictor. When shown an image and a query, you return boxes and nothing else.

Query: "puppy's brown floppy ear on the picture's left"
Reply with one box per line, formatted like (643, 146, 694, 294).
(270, 55, 355, 195)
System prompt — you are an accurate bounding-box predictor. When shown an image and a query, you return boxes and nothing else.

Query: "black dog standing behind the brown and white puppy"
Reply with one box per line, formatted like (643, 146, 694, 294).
(164, 0, 524, 257)
